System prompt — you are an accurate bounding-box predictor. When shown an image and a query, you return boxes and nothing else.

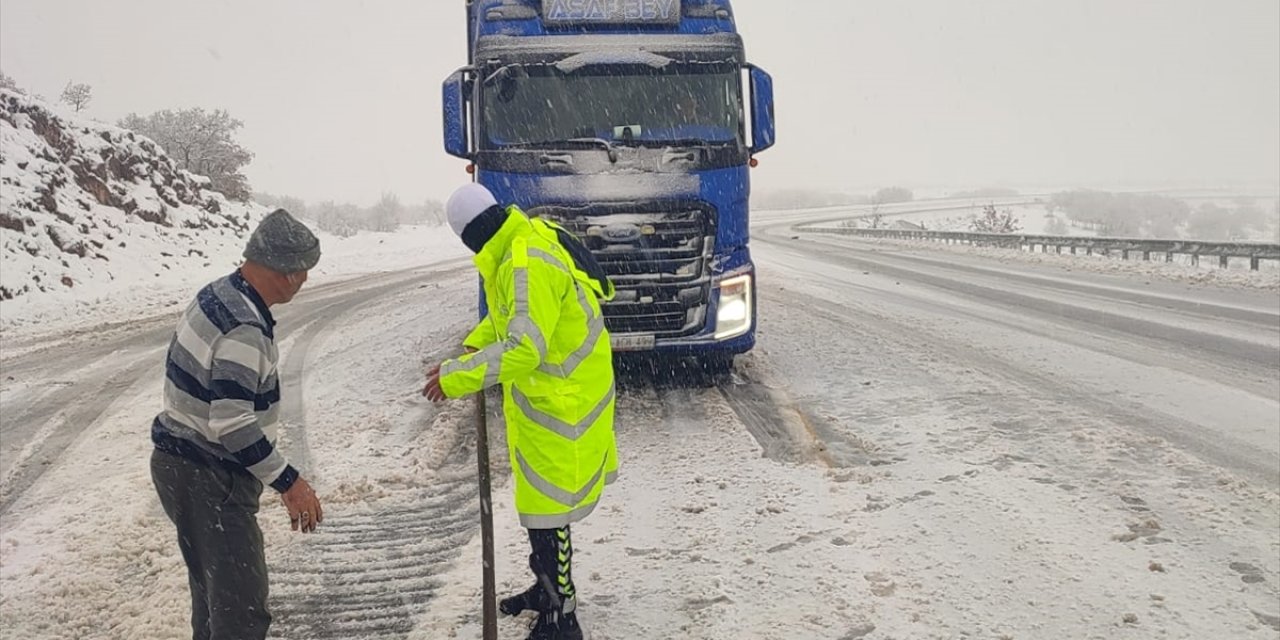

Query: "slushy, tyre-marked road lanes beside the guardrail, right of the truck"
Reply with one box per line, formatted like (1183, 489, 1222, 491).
(756, 222, 1280, 490)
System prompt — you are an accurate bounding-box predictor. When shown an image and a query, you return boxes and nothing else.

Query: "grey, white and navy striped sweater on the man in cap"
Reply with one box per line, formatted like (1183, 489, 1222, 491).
(151, 271, 298, 493)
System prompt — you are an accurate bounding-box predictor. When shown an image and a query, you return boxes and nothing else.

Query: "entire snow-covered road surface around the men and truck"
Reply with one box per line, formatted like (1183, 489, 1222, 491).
(0, 207, 1280, 640)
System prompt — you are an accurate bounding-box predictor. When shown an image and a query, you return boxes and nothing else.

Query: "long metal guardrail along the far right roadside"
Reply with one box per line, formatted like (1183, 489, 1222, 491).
(792, 223, 1280, 271)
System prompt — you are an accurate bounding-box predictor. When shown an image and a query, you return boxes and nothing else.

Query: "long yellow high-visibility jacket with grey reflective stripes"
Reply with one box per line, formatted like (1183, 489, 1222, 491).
(440, 206, 618, 529)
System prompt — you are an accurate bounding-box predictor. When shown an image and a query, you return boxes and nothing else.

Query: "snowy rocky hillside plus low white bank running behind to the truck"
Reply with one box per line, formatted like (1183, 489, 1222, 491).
(0, 90, 465, 337)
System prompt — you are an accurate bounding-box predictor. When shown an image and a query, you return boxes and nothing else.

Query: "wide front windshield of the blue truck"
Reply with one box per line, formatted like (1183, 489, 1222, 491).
(481, 67, 744, 148)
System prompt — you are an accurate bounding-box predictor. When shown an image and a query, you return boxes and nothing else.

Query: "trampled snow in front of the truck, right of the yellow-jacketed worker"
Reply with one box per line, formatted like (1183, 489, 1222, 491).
(410, 269, 1280, 640)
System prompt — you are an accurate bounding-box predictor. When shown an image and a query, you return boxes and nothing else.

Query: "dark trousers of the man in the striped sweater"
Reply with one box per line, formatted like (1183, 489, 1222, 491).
(151, 451, 271, 640)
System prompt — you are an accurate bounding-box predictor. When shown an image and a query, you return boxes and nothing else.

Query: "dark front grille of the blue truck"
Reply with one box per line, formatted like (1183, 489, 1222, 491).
(529, 204, 716, 338)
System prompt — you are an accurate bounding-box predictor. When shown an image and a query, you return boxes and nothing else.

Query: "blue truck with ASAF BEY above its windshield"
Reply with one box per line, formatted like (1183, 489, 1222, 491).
(443, 0, 774, 372)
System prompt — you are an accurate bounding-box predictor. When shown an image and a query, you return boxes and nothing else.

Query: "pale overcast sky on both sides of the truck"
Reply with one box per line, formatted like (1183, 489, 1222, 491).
(0, 0, 1280, 205)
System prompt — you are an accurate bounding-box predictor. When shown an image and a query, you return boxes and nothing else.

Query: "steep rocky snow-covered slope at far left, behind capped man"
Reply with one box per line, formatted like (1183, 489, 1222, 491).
(0, 91, 264, 309)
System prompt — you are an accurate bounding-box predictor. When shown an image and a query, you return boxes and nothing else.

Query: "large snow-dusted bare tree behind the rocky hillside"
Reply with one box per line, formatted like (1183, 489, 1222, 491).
(119, 109, 253, 202)
